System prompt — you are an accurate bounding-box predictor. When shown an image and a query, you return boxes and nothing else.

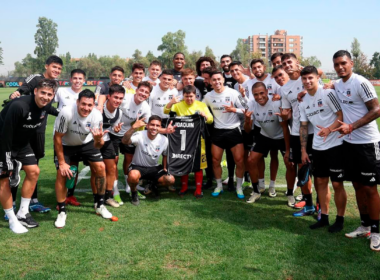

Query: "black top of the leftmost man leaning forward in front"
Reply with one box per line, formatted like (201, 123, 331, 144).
(0, 95, 51, 167)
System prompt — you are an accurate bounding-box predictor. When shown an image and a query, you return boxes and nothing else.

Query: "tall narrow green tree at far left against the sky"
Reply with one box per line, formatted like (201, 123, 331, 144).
(34, 17, 58, 71)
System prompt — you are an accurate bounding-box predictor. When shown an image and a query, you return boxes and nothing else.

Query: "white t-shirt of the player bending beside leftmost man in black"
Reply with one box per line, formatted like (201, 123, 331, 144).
(54, 105, 103, 146)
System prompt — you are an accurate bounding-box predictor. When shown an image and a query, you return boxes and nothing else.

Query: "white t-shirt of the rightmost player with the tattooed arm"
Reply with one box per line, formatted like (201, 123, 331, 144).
(334, 73, 380, 144)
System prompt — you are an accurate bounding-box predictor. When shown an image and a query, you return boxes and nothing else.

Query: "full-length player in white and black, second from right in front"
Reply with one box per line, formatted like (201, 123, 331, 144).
(299, 66, 347, 233)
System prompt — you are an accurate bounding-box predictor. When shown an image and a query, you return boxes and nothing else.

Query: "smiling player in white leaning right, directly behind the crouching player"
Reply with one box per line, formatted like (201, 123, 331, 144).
(110, 82, 151, 205)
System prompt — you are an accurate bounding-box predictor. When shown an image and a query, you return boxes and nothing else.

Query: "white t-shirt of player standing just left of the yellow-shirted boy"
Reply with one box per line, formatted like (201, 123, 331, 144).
(149, 85, 178, 118)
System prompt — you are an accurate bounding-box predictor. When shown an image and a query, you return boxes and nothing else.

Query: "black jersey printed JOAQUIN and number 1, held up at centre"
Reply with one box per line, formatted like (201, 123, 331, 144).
(167, 114, 204, 176)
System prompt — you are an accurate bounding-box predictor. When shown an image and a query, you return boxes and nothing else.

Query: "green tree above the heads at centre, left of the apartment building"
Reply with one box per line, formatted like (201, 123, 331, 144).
(157, 30, 188, 68)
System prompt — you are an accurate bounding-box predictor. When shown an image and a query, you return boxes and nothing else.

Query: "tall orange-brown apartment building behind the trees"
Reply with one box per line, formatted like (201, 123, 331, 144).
(243, 30, 303, 64)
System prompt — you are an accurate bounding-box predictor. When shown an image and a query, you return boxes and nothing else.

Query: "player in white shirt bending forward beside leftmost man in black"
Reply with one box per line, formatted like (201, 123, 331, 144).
(54, 89, 112, 228)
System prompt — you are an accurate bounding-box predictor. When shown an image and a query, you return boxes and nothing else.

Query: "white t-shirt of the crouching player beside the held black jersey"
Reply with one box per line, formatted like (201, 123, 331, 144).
(131, 130, 168, 167)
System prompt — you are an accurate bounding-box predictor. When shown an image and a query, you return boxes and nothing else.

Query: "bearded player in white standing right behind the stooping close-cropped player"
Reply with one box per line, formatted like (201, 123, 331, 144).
(248, 59, 280, 197)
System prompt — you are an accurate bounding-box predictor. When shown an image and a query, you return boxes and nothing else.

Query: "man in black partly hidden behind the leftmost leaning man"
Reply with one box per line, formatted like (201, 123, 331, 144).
(10, 55, 63, 213)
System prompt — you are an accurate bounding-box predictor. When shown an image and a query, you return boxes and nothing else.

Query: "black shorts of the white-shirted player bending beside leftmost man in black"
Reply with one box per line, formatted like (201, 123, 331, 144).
(56, 141, 103, 168)
